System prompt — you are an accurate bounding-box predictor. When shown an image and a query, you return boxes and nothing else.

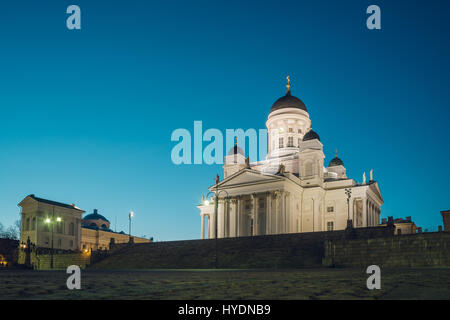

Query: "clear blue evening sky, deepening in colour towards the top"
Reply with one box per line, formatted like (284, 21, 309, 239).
(0, 0, 450, 240)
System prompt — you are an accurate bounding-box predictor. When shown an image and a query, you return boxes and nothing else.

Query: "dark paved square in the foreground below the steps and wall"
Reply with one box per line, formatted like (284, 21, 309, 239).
(0, 268, 450, 299)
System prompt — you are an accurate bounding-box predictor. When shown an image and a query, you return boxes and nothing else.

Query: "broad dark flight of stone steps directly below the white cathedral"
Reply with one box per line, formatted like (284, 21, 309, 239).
(91, 227, 393, 269)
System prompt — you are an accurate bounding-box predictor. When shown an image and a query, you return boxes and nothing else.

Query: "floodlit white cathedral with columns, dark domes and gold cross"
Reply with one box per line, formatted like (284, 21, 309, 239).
(197, 79, 383, 239)
